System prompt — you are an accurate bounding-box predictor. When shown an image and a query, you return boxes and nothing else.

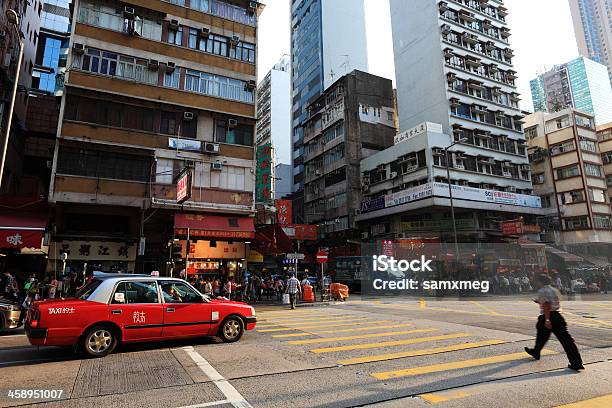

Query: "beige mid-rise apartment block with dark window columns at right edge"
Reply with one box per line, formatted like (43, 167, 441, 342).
(525, 109, 612, 255)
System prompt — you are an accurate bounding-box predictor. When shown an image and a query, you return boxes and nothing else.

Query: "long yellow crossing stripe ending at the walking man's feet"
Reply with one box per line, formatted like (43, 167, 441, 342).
(370, 350, 557, 380)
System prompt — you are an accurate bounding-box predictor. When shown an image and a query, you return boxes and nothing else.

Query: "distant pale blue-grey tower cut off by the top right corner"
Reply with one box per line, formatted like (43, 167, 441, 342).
(569, 0, 612, 82)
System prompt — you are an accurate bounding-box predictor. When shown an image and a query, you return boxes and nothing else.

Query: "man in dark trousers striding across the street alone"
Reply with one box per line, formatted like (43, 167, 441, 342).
(525, 274, 584, 371)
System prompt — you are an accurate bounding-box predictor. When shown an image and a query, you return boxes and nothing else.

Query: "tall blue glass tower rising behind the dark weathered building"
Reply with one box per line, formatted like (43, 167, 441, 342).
(291, 0, 368, 223)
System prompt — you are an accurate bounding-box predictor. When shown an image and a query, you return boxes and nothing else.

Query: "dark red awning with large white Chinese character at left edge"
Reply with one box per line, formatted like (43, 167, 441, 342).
(0, 214, 47, 249)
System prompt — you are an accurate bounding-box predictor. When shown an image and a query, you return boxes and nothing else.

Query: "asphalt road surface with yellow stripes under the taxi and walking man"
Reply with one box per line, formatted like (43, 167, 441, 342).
(0, 296, 612, 408)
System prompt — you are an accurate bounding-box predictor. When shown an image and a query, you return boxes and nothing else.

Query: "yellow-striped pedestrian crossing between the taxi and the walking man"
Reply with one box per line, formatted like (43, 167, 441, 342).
(256, 303, 557, 390)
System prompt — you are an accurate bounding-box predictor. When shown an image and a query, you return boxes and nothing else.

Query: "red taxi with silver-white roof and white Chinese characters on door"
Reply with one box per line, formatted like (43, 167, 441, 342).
(25, 274, 256, 357)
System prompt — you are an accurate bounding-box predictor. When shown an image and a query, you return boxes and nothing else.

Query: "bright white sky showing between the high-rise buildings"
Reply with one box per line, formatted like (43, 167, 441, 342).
(258, 0, 578, 110)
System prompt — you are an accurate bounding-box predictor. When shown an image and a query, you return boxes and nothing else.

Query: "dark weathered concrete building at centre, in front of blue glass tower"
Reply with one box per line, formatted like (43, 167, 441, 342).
(304, 70, 396, 256)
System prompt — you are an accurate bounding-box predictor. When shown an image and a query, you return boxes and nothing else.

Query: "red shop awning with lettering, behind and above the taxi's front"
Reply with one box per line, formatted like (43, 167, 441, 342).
(174, 214, 255, 239)
